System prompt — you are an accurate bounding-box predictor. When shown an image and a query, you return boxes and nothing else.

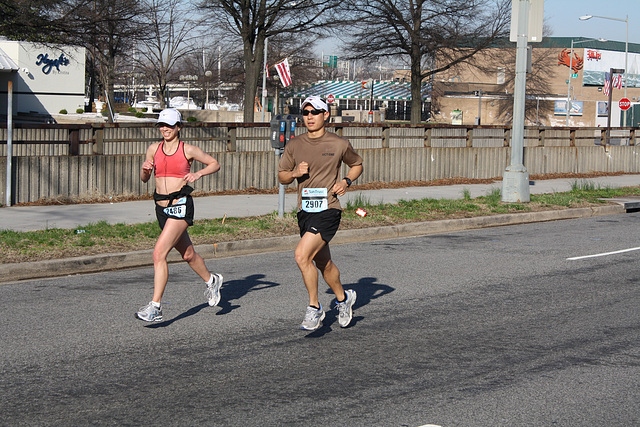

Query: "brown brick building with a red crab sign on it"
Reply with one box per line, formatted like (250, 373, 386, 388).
(432, 37, 640, 126)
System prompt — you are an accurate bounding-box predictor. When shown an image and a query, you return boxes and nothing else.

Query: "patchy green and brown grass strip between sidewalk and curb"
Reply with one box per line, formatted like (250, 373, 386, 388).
(0, 181, 640, 264)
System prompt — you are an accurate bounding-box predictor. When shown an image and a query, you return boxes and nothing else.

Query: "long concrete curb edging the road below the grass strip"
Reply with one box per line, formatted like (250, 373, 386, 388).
(0, 205, 626, 283)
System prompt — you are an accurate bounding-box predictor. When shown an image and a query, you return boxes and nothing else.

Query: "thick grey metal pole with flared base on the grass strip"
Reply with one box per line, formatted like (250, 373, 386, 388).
(502, 0, 531, 203)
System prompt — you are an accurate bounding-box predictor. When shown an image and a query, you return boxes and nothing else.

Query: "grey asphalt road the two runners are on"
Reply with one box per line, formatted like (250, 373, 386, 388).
(0, 214, 640, 427)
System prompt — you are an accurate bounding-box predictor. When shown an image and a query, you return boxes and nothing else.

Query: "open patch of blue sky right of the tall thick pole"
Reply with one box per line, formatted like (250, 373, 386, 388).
(544, 0, 640, 44)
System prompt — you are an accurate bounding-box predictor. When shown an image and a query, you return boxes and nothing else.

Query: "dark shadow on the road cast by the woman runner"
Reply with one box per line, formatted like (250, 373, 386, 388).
(146, 274, 279, 328)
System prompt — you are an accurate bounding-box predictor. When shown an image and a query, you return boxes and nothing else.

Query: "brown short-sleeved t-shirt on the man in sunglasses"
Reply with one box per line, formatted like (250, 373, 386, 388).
(278, 132, 362, 210)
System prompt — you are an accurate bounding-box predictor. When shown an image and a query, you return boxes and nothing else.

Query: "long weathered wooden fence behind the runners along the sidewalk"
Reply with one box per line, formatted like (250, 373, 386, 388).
(0, 123, 640, 204)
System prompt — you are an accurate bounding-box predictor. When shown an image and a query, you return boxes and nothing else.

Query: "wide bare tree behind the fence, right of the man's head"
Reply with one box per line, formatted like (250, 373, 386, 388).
(343, 0, 511, 123)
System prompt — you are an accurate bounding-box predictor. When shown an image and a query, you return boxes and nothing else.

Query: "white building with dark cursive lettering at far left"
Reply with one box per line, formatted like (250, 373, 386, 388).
(0, 40, 85, 117)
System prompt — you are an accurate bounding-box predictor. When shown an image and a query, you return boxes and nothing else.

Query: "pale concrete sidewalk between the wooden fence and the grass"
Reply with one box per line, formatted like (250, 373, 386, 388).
(5, 175, 640, 231)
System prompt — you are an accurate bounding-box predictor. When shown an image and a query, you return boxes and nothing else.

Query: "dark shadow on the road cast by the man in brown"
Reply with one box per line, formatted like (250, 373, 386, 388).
(306, 277, 395, 338)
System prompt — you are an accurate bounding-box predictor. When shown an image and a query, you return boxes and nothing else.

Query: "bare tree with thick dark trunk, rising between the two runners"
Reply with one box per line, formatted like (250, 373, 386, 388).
(202, 0, 344, 122)
